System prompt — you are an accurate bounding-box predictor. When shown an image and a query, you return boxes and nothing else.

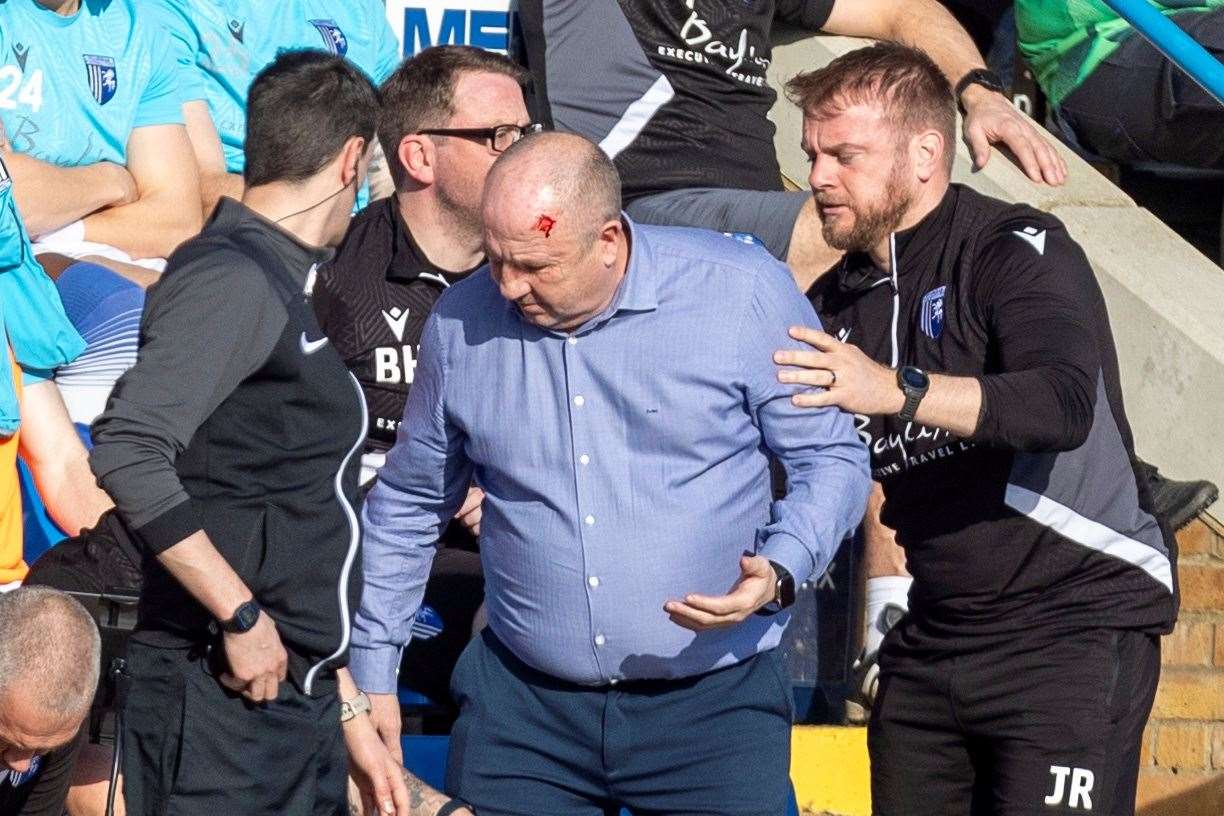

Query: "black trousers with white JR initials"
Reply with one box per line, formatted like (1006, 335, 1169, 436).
(868, 619, 1160, 816)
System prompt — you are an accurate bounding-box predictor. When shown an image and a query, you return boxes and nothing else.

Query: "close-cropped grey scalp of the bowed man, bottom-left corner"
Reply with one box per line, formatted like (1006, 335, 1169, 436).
(0, 586, 102, 717)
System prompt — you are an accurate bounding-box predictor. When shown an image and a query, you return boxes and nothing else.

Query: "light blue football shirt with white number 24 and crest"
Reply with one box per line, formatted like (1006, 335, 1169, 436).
(0, 0, 182, 166)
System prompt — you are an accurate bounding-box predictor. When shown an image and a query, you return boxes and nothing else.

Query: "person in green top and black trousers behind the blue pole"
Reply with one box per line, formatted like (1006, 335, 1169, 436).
(1016, 0, 1224, 170)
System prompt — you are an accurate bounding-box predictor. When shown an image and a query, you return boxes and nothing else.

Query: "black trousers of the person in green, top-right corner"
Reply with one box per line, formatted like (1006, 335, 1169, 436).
(1059, 9, 1224, 170)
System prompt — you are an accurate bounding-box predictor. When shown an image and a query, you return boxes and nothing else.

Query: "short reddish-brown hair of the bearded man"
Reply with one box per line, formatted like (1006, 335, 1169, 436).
(786, 43, 956, 170)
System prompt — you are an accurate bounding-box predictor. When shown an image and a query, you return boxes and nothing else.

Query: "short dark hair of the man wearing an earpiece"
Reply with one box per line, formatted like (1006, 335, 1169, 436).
(242, 50, 379, 187)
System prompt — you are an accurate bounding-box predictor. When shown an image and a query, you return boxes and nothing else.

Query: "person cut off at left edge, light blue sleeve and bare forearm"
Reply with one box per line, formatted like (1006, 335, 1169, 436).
(0, 160, 110, 591)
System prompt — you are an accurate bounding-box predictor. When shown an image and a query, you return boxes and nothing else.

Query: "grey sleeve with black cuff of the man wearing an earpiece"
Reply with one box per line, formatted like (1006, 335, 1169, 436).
(89, 257, 288, 553)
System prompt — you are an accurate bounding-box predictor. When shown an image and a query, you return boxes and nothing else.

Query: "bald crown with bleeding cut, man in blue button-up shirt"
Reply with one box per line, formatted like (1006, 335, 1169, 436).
(483, 132, 621, 243)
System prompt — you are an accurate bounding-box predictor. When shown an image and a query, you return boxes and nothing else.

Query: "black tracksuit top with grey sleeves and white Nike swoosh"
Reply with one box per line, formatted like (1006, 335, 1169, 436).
(91, 199, 366, 695)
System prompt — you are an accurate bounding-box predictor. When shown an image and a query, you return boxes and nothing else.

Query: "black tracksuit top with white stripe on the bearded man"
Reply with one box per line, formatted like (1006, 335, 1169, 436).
(808, 185, 1176, 636)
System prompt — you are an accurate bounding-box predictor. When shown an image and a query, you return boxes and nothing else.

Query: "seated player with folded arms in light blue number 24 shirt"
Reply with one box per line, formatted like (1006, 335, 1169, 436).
(0, 0, 201, 269)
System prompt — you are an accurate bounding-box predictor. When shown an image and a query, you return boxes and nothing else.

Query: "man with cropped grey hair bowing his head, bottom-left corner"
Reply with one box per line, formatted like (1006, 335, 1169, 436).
(0, 586, 102, 816)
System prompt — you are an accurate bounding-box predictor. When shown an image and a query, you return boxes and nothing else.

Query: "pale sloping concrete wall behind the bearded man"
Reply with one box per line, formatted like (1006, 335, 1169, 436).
(770, 29, 1224, 504)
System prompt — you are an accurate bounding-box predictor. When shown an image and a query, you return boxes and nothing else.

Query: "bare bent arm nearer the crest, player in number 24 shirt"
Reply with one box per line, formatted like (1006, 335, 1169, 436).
(84, 124, 203, 258)
